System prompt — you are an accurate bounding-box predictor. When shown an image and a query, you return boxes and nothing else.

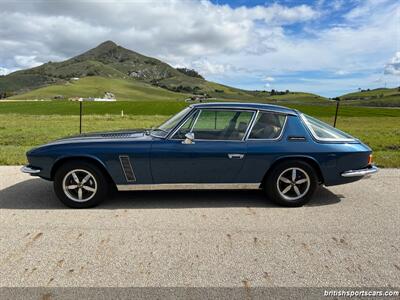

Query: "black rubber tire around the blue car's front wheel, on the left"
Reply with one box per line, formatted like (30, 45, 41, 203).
(54, 161, 110, 208)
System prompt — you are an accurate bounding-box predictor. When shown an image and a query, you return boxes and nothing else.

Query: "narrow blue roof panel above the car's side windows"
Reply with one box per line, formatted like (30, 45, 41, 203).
(190, 102, 297, 115)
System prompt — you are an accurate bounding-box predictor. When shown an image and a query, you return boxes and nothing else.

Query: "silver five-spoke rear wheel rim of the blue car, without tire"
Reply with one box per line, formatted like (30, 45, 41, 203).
(276, 167, 311, 201)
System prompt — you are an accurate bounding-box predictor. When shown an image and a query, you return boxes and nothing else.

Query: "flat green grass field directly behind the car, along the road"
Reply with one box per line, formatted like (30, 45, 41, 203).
(0, 101, 400, 167)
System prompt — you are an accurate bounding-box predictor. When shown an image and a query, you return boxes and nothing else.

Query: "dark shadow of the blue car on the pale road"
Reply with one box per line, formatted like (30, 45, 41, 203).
(0, 179, 343, 209)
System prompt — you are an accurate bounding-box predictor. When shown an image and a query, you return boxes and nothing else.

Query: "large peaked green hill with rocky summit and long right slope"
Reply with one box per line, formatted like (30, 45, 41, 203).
(0, 41, 325, 103)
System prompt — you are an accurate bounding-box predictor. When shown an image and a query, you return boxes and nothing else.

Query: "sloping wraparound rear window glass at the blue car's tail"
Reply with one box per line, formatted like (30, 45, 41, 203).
(301, 114, 354, 141)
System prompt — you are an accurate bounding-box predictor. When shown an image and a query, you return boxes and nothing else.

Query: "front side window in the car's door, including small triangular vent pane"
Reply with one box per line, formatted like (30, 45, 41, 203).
(174, 109, 253, 141)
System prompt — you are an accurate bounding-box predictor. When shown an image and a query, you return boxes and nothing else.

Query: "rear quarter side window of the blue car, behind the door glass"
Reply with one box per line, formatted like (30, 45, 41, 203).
(249, 112, 286, 139)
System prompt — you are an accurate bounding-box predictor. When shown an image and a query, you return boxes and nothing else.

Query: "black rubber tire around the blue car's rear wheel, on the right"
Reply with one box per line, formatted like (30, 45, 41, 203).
(264, 160, 318, 207)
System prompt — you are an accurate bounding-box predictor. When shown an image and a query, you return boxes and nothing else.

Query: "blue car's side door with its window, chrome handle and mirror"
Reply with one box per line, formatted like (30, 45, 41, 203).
(150, 109, 255, 184)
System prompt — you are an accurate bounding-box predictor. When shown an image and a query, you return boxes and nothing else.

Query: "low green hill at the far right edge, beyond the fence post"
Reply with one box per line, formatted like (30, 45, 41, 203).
(339, 87, 400, 107)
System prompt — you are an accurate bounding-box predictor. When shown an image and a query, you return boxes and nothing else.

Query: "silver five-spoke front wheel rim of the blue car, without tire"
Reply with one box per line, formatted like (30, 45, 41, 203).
(62, 169, 97, 202)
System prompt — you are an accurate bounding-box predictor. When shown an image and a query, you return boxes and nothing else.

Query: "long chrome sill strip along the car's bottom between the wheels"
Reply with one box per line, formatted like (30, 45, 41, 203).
(117, 183, 260, 191)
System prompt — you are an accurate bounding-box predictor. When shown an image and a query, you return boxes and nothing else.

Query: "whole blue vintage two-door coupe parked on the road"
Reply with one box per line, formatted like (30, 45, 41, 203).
(22, 103, 378, 208)
